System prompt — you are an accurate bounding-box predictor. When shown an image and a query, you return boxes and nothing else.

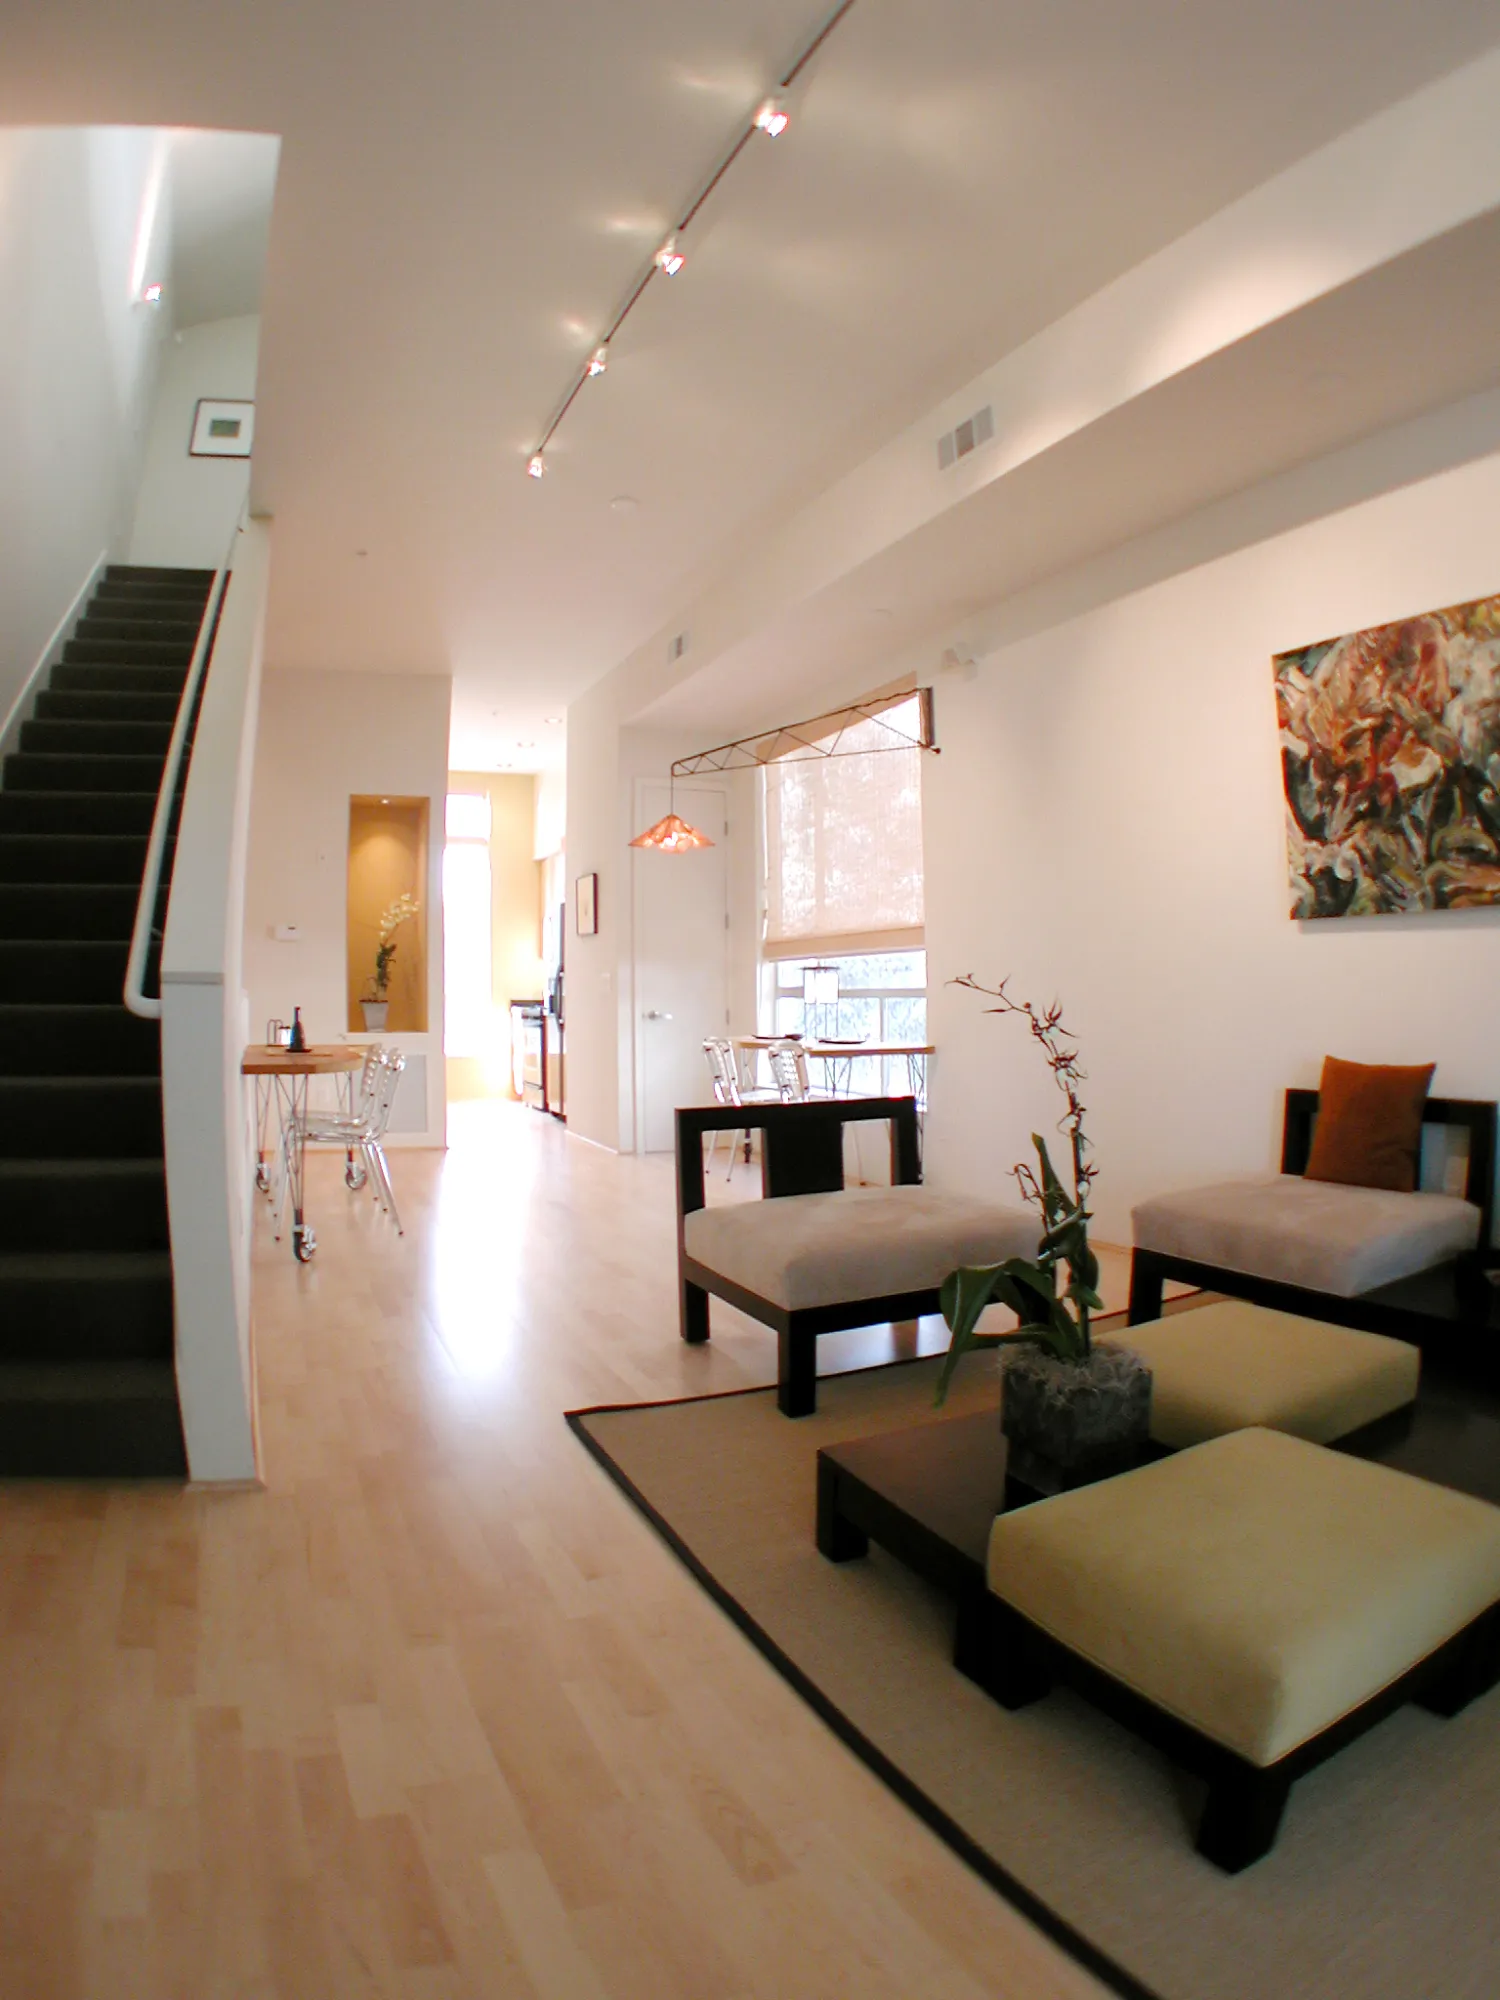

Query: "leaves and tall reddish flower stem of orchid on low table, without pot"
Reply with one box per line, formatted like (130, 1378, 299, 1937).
(936, 974, 1104, 1402)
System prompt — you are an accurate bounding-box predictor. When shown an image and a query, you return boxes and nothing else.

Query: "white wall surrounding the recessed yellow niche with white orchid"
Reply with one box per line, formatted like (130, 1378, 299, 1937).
(244, 672, 452, 1146)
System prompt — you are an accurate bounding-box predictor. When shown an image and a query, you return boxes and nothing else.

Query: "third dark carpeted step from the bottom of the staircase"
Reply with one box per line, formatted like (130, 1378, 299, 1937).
(0, 1160, 170, 1250)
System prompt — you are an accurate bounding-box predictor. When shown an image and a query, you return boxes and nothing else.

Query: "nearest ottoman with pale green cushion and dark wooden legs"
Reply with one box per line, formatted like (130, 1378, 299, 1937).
(986, 1430, 1500, 1868)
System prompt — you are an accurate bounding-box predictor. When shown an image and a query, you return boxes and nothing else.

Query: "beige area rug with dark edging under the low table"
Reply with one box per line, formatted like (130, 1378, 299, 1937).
(568, 1356, 1500, 2000)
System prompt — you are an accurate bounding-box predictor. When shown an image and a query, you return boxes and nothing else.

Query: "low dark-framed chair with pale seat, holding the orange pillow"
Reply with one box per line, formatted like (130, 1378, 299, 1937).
(1130, 1090, 1496, 1336)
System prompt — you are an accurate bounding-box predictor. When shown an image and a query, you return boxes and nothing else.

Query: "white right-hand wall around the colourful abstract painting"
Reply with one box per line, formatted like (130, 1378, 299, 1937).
(926, 416, 1500, 1242)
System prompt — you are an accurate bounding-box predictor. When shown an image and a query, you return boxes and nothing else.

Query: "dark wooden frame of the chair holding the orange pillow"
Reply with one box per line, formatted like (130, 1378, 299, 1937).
(1130, 1090, 1496, 1346)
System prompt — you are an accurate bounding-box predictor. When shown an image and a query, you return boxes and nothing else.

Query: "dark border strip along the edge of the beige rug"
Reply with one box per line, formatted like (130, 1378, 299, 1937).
(564, 1354, 1162, 2000)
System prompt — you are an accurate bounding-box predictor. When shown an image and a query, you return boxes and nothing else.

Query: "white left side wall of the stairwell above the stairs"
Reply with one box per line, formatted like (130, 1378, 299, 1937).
(0, 126, 170, 714)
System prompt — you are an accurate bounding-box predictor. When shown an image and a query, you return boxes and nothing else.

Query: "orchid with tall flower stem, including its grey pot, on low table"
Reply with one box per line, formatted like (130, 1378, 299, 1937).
(936, 976, 1152, 1492)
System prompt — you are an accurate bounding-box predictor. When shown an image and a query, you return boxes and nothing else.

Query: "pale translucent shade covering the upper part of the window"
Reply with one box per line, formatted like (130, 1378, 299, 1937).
(764, 694, 926, 960)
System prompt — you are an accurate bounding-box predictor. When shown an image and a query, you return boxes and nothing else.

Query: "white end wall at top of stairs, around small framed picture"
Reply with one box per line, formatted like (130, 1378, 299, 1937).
(130, 314, 260, 570)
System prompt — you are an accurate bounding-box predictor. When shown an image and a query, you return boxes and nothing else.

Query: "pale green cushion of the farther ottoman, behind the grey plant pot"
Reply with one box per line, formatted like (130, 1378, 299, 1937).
(1120, 1298, 1422, 1450)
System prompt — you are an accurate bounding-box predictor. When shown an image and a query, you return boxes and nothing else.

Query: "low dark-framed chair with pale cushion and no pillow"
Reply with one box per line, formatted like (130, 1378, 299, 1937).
(676, 1098, 1038, 1416)
